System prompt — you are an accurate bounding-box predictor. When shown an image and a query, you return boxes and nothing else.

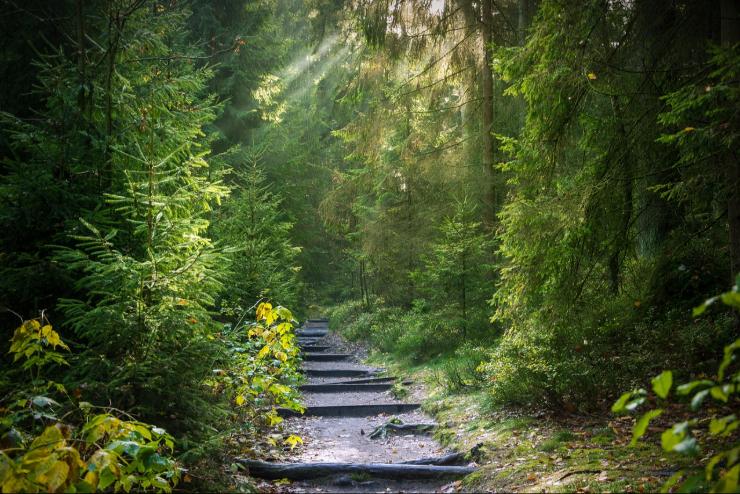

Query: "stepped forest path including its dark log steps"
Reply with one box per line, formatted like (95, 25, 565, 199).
(250, 320, 473, 493)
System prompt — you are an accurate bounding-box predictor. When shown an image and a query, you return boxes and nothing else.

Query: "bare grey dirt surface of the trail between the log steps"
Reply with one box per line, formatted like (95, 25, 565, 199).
(264, 320, 474, 493)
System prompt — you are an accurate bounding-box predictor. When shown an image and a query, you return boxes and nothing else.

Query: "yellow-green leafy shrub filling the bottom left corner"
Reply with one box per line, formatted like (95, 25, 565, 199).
(0, 317, 180, 492)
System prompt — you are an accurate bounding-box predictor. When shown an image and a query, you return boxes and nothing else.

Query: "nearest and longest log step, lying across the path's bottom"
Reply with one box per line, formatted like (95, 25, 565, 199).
(236, 459, 476, 480)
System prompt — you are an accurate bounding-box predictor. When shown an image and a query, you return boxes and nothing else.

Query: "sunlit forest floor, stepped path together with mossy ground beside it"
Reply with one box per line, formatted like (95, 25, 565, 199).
(244, 323, 704, 493)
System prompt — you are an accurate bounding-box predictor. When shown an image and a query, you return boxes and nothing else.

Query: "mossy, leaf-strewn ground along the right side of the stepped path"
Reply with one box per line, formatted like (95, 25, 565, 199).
(370, 357, 709, 493)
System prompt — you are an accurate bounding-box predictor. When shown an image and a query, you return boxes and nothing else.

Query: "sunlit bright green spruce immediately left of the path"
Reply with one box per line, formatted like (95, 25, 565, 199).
(40, 5, 227, 435)
